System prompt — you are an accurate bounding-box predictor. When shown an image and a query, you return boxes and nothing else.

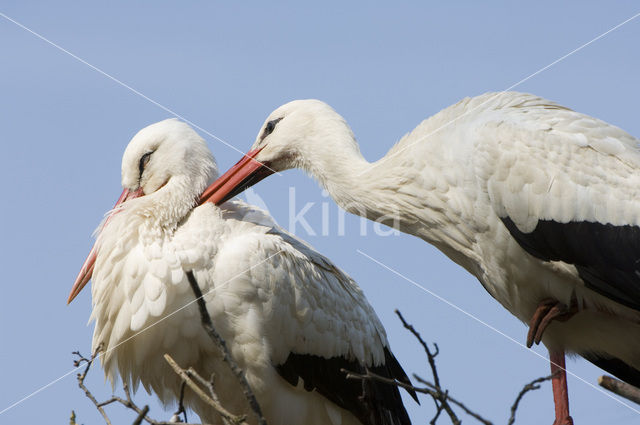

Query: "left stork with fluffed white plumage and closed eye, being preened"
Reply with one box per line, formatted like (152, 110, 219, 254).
(69, 120, 415, 425)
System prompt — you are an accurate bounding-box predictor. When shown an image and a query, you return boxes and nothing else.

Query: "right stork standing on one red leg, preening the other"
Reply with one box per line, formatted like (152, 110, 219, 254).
(203, 92, 640, 425)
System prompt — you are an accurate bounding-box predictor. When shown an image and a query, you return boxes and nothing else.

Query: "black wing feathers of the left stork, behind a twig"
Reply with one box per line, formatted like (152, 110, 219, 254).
(276, 348, 418, 425)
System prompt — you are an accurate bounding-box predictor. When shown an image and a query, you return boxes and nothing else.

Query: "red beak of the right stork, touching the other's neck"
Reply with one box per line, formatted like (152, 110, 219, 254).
(200, 148, 273, 205)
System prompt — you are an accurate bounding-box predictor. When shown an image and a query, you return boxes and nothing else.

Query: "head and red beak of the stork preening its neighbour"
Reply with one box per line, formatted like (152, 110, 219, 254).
(200, 99, 359, 204)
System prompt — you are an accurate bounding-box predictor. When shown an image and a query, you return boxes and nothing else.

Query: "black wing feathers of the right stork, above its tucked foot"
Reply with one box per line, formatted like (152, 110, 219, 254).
(501, 217, 640, 311)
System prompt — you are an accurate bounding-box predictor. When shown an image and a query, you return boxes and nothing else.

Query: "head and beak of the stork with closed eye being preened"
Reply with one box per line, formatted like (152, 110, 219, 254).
(67, 119, 218, 303)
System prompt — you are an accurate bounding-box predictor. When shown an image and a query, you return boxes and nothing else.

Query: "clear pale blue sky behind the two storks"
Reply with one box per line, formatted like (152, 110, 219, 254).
(0, 1, 640, 425)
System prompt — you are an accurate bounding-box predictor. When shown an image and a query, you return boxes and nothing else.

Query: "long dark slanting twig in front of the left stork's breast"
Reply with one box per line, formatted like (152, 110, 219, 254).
(187, 271, 267, 425)
